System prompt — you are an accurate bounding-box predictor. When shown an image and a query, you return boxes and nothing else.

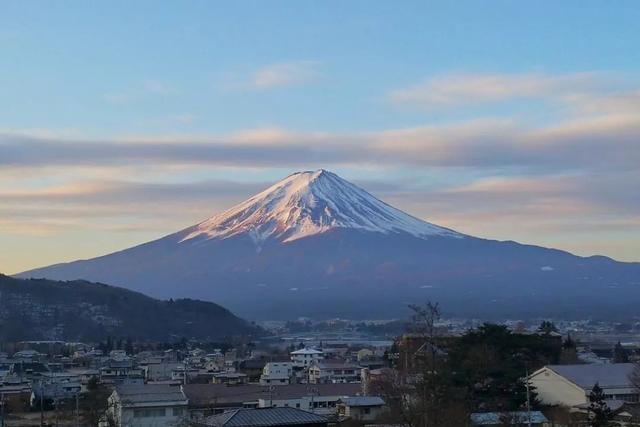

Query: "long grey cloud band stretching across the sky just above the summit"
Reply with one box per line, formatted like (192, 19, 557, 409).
(0, 109, 640, 173)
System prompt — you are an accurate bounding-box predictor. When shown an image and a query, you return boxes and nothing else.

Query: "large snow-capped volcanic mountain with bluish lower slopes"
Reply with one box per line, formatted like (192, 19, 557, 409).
(18, 170, 640, 319)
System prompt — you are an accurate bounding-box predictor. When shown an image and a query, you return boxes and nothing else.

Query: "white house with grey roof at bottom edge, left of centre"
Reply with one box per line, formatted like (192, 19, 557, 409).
(104, 384, 189, 427)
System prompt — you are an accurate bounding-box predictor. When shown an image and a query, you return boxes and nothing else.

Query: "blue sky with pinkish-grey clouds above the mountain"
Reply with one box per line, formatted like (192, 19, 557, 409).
(0, 1, 640, 272)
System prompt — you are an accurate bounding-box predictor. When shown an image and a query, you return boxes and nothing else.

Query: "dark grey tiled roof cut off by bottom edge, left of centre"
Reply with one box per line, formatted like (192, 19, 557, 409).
(203, 408, 328, 427)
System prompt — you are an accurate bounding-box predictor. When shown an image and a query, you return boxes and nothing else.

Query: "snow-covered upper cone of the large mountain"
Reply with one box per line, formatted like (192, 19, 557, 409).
(182, 169, 463, 242)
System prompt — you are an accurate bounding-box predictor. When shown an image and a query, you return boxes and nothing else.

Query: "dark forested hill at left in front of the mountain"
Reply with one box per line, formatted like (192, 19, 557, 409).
(0, 274, 260, 341)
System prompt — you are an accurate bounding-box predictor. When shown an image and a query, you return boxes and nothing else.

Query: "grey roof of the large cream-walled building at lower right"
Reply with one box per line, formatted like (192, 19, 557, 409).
(547, 363, 635, 390)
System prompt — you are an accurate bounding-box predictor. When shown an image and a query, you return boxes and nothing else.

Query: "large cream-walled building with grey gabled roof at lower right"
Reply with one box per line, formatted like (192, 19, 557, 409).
(529, 363, 640, 407)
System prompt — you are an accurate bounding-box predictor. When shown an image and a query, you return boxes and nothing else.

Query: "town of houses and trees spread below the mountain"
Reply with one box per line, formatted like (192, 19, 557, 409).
(0, 303, 640, 427)
